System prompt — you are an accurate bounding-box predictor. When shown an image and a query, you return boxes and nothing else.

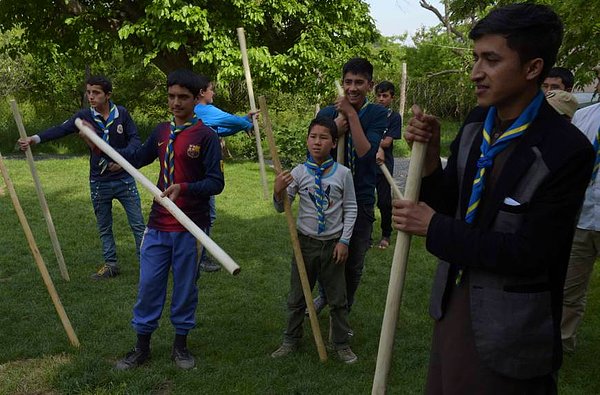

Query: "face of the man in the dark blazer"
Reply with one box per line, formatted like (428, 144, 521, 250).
(471, 34, 541, 116)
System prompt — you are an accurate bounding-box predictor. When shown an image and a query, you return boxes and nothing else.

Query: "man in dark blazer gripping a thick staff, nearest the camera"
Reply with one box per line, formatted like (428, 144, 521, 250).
(393, 4, 594, 394)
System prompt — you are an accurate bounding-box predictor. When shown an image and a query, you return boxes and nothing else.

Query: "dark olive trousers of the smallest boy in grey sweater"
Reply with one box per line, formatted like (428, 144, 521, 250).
(284, 234, 350, 349)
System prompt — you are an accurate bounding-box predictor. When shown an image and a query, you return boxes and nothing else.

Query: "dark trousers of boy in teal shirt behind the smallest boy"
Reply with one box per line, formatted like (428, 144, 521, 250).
(319, 204, 375, 311)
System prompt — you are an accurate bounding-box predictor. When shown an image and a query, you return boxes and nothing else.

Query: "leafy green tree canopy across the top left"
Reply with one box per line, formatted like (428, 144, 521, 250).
(0, 0, 378, 91)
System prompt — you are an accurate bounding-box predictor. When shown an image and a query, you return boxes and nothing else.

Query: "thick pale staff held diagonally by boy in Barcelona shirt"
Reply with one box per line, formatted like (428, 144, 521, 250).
(75, 118, 240, 275)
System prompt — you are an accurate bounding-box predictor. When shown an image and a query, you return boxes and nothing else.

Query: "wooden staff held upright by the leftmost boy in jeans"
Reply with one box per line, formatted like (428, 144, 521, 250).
(10, 100, 69, 281)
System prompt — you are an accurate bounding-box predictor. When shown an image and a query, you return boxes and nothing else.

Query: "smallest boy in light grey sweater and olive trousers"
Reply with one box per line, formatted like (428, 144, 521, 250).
(271, 117, 357, 363)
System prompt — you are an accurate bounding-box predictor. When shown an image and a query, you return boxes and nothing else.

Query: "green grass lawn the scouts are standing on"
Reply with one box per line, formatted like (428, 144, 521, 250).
(0, 157, 600, 394)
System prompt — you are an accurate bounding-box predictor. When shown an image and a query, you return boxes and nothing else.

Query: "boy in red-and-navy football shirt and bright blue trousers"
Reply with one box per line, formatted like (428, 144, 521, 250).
(116, 70, 225, 370)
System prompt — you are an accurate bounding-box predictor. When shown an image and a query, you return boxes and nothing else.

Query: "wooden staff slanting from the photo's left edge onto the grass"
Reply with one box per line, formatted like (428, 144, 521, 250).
(0, 153, 79, 347)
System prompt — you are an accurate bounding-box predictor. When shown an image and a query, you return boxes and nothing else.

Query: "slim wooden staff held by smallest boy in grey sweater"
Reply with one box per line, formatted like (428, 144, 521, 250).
(258, 96, 327, 362)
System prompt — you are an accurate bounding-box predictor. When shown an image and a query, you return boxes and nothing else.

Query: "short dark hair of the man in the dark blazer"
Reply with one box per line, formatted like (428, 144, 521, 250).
(469, 3, 563, 85)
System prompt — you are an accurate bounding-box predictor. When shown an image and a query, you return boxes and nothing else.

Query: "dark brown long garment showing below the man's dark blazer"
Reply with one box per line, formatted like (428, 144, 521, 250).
(425, 274, 557, 395)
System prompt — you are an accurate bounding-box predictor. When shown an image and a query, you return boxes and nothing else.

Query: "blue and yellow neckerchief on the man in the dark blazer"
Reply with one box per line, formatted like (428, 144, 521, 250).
(465, 91, 544, 224)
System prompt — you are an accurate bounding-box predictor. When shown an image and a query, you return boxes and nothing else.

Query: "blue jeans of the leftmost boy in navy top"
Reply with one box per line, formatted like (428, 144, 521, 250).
(90, 177, 146, 266)
